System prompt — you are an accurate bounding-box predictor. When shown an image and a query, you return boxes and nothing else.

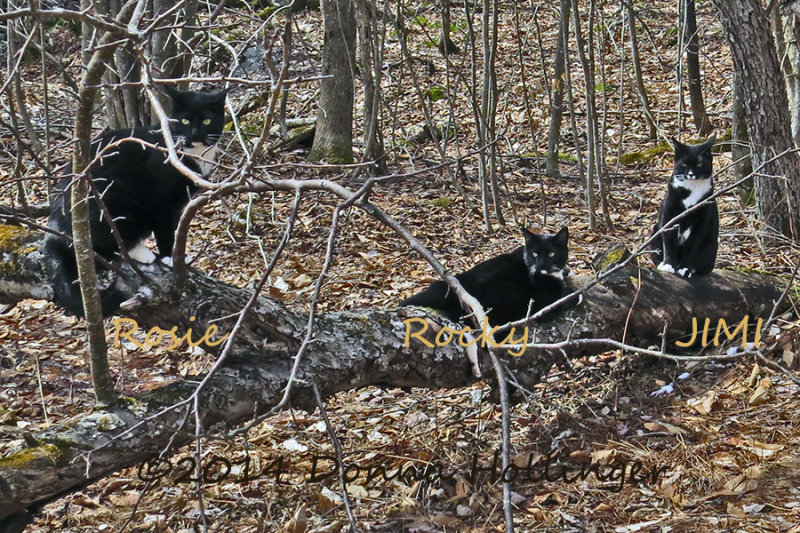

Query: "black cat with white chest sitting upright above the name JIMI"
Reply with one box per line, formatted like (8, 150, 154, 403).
(652, 137, 719, 278)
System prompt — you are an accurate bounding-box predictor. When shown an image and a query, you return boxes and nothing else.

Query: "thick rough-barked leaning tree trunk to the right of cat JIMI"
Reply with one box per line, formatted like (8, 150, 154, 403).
(714, 0, 800, 241)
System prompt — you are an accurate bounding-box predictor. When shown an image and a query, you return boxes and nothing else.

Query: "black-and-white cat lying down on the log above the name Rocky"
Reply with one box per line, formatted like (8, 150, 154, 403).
(400, 228, 577, 326)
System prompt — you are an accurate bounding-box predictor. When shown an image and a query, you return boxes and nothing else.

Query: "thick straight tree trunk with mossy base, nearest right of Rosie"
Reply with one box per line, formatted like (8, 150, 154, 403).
(308, 0, 356, 164)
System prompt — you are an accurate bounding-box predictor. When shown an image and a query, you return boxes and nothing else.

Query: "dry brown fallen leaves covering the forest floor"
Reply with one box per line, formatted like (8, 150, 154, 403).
(0, 1, 800, 533)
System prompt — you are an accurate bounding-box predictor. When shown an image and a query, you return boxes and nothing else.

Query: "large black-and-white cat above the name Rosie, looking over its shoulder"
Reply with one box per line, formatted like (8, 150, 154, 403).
(44, 86, 227, 317)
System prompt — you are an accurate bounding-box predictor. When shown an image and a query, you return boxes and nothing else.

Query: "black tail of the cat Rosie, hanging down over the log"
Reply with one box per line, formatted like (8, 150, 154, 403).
(44, 235, 126, 318)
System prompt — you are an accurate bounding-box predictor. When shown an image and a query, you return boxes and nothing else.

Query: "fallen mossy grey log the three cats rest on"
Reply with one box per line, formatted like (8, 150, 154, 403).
(0, 222, 781, 529)
